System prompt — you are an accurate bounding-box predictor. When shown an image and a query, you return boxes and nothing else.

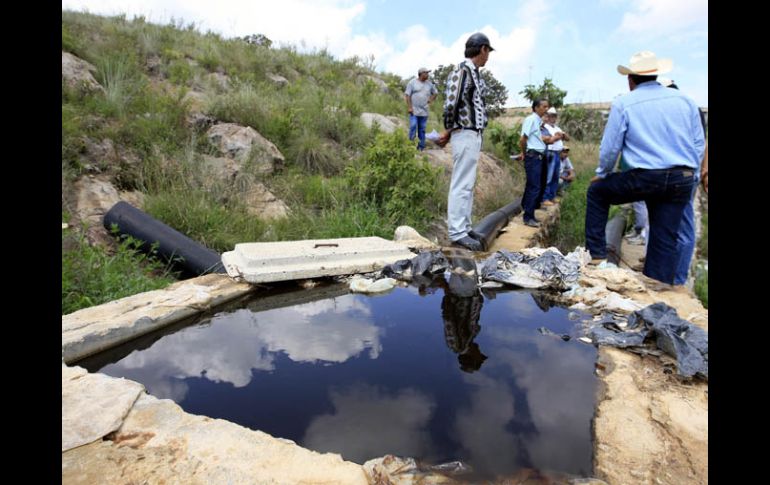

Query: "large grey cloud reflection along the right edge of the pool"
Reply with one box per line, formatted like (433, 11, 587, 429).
(488, 327, 596, 473)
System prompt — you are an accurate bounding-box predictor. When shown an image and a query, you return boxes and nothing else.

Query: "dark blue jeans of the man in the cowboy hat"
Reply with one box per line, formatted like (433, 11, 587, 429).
(585, 167, 695, 284)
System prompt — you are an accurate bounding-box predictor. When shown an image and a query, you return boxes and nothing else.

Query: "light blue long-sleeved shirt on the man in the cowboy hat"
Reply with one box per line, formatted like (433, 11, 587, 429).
(596, 81, 706, 178)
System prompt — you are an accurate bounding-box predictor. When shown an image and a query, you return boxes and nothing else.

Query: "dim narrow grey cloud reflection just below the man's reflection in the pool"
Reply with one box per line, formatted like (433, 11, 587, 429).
(453, 374, 518, 473)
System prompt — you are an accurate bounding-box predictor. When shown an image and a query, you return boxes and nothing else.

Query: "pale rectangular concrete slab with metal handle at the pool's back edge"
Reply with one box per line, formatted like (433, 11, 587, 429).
(222, 237, 414, 283)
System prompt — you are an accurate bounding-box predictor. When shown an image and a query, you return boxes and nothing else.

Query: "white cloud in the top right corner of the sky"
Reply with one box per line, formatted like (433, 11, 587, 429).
(618, 0, 708, 38)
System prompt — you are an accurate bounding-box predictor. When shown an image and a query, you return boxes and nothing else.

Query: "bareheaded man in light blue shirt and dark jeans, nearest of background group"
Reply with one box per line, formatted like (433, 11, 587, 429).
(519, 98, 562, 227)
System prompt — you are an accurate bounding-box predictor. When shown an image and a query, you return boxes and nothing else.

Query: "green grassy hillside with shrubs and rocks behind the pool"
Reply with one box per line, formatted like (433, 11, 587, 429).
(62, 11, 446, 311)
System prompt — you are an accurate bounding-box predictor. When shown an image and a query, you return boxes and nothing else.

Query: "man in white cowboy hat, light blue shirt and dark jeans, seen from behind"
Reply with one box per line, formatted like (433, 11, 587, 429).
(585, 51, 705, 284)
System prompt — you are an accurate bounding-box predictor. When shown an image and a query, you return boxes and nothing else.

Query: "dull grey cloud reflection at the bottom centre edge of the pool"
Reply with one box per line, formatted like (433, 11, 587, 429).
(302, 384, 435, 463)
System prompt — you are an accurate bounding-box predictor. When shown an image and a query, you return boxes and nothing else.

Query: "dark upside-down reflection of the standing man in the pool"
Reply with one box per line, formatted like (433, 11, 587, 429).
(441, 255, 487, 372)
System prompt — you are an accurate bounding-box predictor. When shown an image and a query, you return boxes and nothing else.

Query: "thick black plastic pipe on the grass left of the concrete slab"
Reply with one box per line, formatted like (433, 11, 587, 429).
(103, 201, 225, 277)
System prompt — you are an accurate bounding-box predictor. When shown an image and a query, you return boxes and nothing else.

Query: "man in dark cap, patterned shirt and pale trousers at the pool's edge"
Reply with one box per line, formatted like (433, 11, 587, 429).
(436, 32, 494, 251)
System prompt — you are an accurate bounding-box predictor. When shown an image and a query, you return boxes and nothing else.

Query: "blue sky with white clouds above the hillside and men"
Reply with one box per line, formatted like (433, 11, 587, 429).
(62, 0, 708, 106)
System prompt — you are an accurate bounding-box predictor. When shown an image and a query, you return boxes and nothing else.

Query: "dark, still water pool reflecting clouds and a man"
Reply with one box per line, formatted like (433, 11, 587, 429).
(79, 276, 596, 477)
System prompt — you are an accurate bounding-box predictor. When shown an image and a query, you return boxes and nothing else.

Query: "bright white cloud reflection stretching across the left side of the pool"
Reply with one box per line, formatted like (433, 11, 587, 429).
(110, 297, 382, 402)
